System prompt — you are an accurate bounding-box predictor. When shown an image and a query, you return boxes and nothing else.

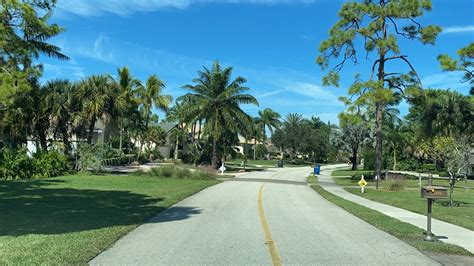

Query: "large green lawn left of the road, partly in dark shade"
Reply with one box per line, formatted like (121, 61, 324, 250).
(0, 175, 218, 265)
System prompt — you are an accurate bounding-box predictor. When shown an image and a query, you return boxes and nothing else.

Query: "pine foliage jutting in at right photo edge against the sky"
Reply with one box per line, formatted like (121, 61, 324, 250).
(438, 43, 474, 95)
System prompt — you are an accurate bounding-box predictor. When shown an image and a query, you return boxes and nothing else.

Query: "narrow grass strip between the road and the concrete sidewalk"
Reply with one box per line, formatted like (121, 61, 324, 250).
(311, 185, 473, 256)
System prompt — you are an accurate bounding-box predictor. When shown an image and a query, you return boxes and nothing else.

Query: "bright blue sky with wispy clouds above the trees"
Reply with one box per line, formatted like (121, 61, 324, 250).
(42, 0, 474, 123)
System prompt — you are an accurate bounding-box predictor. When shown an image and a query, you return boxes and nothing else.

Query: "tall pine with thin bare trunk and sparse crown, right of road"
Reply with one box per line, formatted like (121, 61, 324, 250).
(317, 0, 441, 187)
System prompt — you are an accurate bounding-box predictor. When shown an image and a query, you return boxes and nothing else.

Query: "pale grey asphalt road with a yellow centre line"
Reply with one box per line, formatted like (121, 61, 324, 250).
(91, 165, 436, 265)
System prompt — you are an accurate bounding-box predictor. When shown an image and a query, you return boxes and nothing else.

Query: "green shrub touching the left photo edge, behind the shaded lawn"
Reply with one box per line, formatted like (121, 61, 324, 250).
(0, 148, 34, 180)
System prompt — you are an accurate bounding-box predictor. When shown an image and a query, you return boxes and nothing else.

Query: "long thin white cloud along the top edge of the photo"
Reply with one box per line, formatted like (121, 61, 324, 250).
(58, 0, 315, 16)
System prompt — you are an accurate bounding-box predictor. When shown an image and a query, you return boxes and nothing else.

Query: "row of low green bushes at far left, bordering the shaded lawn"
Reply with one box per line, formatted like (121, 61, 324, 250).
(0, 148, 71, 180)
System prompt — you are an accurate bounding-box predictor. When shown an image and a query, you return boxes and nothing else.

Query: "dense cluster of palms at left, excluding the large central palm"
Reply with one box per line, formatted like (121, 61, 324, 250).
(0, 67, 172, 156)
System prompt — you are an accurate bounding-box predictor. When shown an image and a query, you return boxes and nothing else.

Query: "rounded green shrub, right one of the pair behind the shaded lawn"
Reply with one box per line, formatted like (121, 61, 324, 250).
(33, 151, 71, 178)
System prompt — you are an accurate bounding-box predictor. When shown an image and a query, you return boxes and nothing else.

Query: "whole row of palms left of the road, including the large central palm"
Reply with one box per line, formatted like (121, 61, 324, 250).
(0, 62, 286, 167)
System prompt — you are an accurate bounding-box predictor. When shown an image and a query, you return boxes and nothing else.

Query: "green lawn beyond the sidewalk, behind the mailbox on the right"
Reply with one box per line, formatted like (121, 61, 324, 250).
(334, 177, 474, 230)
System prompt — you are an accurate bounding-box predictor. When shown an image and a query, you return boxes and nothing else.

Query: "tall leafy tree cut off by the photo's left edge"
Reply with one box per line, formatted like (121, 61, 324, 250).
(0, 0, 68, 147)
